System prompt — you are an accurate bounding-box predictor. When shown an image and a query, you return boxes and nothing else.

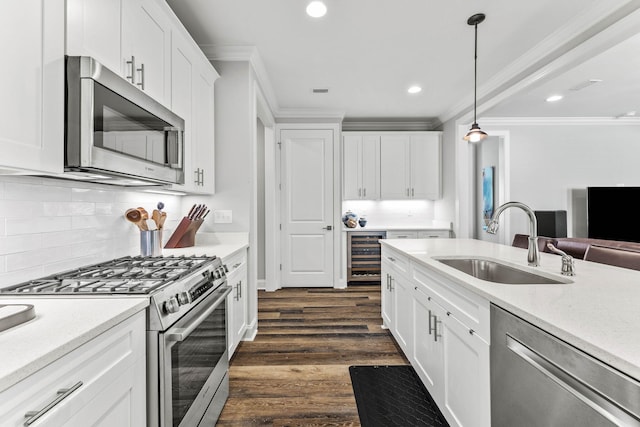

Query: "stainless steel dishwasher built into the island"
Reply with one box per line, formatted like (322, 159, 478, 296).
(491, 305, 640, 427)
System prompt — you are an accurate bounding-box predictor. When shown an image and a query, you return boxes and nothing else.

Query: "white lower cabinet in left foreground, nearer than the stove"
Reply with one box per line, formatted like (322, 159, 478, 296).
(0, 311, 147, 427)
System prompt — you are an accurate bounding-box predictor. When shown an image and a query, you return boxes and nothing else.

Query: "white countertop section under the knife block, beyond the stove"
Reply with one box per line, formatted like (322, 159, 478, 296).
(162, 232, 249, 260)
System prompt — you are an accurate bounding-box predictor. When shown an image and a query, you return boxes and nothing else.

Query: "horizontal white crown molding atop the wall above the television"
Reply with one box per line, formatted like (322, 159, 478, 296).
(479, 117, 640, 127)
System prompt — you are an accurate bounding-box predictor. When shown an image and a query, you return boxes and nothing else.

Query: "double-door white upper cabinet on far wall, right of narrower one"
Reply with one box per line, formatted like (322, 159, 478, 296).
(380, 132, 441, 200)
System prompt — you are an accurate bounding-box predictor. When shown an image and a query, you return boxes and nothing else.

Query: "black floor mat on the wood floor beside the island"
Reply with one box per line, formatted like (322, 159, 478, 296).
(349, 365, 449, 427)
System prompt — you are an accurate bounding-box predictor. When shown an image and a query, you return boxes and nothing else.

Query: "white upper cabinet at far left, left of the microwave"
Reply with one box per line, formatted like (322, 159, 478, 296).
(0, 0, 65, 173)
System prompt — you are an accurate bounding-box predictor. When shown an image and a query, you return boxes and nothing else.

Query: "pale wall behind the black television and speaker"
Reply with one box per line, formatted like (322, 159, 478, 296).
(482, 120, 640, 236)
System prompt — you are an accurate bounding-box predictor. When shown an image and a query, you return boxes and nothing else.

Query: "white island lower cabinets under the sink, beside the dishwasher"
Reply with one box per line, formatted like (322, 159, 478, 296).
(382, 246, 491, 427)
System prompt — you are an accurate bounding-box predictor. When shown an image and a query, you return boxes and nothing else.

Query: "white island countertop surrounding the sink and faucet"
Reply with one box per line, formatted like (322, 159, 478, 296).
(381, 239, 640, 380)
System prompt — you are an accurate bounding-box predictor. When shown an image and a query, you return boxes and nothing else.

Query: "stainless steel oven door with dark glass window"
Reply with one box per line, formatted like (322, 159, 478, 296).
(159, 286, 231, 427)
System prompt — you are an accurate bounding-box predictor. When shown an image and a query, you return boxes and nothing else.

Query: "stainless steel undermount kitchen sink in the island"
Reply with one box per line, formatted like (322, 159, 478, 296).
(434, 257, 572, 285)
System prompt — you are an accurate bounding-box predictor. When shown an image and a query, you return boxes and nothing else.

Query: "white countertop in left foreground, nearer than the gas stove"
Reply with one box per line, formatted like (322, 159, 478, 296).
(0, 297, 148, 391)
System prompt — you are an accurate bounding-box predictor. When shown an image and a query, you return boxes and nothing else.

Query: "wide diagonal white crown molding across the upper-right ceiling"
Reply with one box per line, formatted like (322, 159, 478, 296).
(439, 0, 640, 122)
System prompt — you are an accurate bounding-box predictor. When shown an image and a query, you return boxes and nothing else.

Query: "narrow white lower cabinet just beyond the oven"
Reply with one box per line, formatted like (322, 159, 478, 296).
(224, 250, 248, 359)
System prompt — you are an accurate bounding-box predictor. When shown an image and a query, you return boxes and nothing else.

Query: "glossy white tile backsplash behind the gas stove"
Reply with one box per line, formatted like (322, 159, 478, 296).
(0, 176, 184, 287)
